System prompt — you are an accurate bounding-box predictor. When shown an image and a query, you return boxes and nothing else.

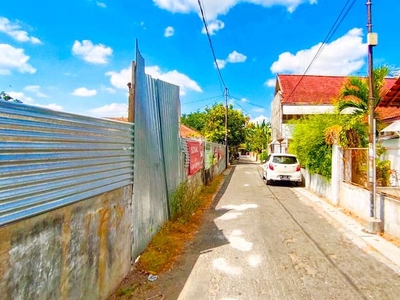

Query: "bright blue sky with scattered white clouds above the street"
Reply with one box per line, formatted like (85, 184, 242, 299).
(0, 0, 400, 120)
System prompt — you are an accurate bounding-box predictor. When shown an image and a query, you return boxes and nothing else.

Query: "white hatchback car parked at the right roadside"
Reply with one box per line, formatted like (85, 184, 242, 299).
(263, 153, 302, 184)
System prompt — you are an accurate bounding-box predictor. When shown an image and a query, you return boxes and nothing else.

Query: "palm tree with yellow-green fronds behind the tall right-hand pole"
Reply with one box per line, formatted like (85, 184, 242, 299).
(338, 66, 389, 115)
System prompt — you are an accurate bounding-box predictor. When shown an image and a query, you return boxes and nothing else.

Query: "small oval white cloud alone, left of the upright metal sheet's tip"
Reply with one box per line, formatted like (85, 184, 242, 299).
(72, 40, 113, 64)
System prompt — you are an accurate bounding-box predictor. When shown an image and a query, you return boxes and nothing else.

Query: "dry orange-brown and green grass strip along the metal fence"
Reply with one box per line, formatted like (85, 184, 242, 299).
(138, 175, 223, 274)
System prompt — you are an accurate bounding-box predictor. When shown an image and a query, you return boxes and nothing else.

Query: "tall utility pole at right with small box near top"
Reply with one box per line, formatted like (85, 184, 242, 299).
(367, 0, 378, 218)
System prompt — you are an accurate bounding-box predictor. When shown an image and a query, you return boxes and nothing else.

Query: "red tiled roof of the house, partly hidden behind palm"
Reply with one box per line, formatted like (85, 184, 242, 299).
(277, 74, 396, 105)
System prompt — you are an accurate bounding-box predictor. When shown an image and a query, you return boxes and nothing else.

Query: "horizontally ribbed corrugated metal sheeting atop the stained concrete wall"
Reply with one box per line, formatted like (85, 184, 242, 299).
(0, 101, 134, 225)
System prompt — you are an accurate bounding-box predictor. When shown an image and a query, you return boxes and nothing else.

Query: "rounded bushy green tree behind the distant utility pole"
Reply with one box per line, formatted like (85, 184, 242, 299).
(201, 103, 249, 147)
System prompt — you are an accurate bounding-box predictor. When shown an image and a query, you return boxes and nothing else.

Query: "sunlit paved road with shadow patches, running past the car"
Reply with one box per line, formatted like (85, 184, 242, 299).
(179, 160, 400, 300)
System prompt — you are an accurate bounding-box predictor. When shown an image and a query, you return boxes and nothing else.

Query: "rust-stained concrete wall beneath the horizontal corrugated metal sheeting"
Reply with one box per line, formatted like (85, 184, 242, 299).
(0, 186, 132, 300)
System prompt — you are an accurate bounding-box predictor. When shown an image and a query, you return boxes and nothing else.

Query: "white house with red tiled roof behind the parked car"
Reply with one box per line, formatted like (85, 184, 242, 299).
(270, 74, 397, 152)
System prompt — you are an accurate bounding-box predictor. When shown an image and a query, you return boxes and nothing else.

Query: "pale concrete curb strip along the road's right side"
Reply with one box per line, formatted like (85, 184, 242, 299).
(292, 188, 400, 273)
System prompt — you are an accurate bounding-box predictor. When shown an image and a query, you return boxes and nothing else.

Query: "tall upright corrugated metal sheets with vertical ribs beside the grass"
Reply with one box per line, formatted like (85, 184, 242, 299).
(132, 44, 181, 257)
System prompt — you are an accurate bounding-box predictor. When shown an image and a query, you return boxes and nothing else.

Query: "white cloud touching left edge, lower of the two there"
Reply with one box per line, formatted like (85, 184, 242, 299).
(0, 44, 36, 75)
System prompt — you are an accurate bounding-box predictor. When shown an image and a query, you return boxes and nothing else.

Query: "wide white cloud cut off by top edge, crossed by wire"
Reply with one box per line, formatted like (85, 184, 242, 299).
(153, 0, 317, 20)
